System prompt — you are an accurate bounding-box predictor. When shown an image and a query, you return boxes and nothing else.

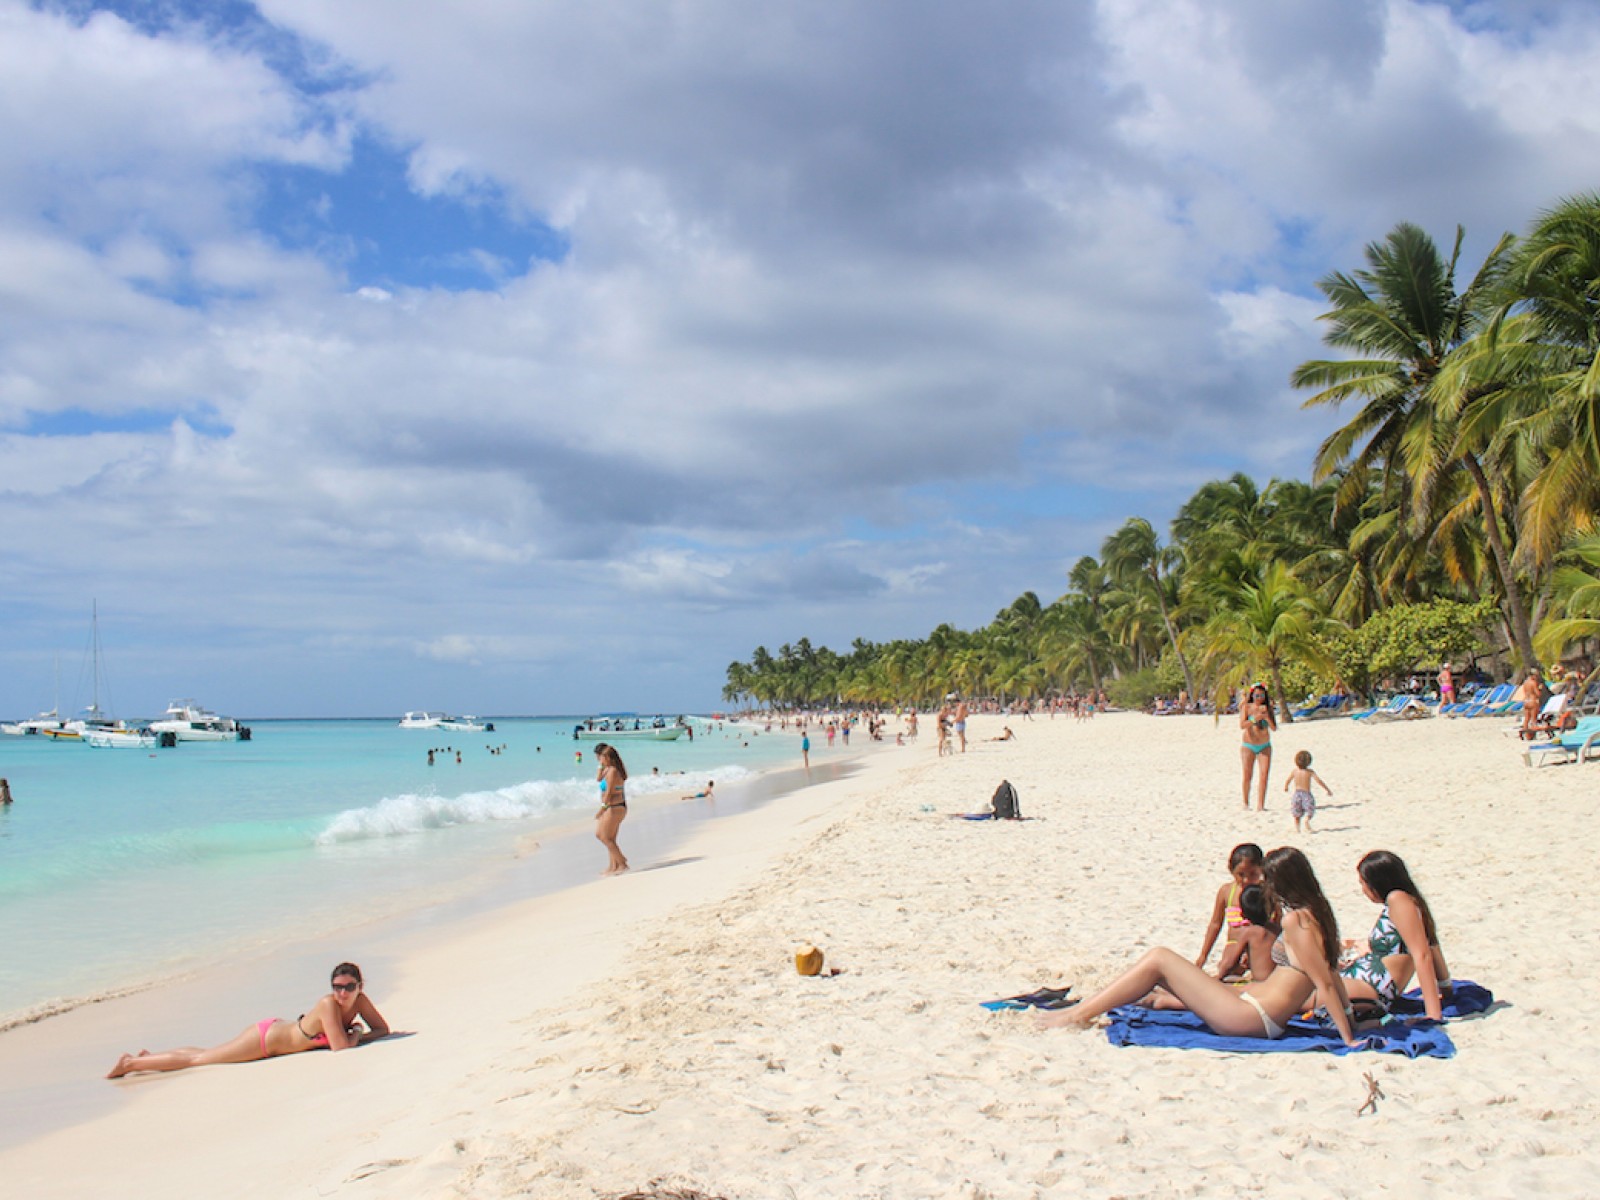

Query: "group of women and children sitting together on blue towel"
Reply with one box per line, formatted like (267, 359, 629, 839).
(1040, 843, 1450, 1045)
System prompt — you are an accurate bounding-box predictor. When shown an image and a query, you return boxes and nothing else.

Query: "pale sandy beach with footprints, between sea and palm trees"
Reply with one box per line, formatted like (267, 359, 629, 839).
(0, 715, 1600, 1200)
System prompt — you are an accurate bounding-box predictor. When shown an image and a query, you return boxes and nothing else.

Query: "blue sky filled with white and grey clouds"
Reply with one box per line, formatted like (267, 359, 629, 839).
(0, 0, 1600, 717)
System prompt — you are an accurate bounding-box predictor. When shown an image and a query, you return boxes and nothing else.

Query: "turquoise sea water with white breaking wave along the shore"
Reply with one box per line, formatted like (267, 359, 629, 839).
(0, 718, 795, 1027)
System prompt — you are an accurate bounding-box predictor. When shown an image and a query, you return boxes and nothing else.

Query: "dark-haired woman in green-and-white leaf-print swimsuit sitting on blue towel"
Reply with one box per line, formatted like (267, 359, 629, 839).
(1341, 850, 1450, 1021)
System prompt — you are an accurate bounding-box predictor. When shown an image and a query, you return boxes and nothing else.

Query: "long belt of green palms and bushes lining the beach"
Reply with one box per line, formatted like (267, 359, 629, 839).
(723, 192, 1600, 707)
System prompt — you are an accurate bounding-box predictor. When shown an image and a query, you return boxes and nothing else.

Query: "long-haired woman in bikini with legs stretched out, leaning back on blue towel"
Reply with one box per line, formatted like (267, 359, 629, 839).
(1040, 846, 1357, 1046)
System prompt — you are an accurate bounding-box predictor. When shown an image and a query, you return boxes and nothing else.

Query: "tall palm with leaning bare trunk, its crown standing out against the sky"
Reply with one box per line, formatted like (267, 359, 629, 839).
(1290, 224, 1538, 666)
